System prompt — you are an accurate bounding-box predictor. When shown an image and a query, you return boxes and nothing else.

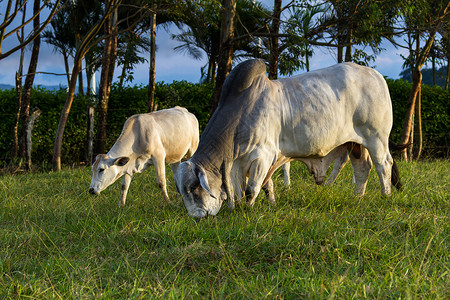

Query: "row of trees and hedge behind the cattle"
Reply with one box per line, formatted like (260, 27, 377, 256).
(0, 0, 450, 170)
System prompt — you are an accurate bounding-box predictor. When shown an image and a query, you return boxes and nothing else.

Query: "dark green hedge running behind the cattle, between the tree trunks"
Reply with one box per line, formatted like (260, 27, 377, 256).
(0, 79, 450, 168)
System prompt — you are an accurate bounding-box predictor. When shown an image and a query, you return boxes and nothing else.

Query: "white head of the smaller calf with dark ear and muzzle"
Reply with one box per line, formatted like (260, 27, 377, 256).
(89, 154, 130, 195)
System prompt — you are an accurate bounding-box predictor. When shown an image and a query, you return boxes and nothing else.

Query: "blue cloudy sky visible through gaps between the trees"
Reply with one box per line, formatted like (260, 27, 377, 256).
(0, 0, 412, 86)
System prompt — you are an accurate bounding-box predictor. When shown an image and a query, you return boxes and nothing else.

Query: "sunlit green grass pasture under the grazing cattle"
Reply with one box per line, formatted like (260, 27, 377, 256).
(0, 161, 450, 299)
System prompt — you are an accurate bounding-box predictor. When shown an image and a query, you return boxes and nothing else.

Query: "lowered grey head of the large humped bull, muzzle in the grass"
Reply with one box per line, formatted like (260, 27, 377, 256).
(175, 160, 226, 218)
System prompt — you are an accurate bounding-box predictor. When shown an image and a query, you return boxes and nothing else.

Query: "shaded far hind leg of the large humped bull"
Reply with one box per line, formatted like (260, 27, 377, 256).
(350, 148, 372, 196)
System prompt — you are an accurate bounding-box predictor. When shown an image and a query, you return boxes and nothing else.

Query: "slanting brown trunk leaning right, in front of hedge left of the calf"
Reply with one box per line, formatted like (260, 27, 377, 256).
(52, 60, 81, 171)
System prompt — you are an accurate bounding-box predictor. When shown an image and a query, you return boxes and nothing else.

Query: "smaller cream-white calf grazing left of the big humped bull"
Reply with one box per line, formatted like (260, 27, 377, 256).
(89, 106, 199, 206)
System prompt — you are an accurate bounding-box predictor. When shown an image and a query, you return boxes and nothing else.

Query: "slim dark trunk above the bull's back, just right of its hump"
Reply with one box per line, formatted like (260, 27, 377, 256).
(269, 0, 281, 79)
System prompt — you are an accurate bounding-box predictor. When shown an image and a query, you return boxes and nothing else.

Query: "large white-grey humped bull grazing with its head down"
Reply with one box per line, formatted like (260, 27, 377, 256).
(176, 60, 400, 217)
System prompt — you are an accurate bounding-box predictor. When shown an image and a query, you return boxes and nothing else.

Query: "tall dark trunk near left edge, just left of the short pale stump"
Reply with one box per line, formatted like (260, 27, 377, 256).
(19, 0, 41, 159)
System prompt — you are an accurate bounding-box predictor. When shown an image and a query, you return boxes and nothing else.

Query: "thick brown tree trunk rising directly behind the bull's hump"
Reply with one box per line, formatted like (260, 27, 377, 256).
(211, 0, 236, 112)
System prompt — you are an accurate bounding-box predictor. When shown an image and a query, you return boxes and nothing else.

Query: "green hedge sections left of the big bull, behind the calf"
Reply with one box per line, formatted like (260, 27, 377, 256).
(0, 81, 213, 169)
